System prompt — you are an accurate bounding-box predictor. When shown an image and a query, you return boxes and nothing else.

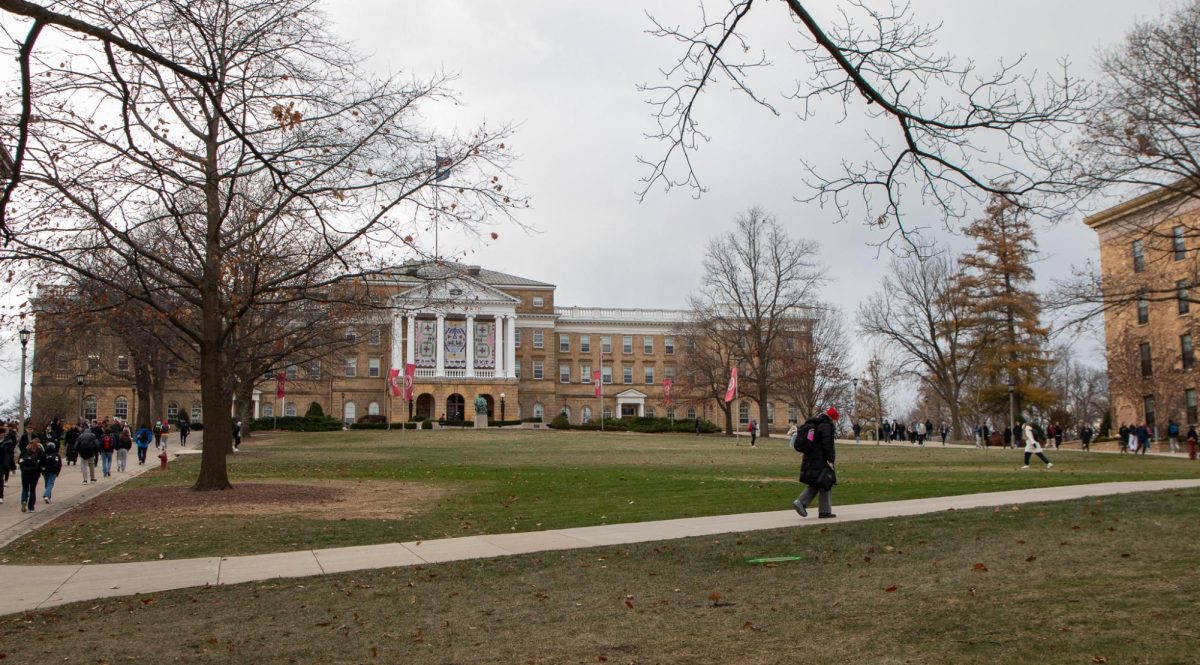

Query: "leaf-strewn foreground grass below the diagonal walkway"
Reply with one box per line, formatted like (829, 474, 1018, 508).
(0, 484, 1200, 665)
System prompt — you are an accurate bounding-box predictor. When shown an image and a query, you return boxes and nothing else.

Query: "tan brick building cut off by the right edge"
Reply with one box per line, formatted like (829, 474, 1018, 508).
(1084, 191, 1200, 424)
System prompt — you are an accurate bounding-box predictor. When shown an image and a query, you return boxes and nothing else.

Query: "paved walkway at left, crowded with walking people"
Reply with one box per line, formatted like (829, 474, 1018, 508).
(0, 432, 200, 547)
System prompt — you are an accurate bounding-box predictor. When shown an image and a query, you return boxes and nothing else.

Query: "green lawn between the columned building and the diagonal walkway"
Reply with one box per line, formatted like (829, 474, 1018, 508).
(0, 430, 1200, 563)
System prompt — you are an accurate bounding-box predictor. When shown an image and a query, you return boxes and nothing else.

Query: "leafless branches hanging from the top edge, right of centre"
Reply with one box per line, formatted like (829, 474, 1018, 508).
(641, 0, 1088, 232)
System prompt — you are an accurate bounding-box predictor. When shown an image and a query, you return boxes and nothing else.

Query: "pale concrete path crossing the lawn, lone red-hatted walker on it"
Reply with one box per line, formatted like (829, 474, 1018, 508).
(0, 479, 1200, 615)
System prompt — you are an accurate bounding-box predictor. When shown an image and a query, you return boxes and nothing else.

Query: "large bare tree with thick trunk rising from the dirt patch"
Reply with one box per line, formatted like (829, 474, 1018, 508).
(0, 0, 515, 490)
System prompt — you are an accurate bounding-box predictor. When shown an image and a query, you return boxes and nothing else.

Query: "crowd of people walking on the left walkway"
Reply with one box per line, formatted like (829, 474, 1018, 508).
(0, 418, 187, 513)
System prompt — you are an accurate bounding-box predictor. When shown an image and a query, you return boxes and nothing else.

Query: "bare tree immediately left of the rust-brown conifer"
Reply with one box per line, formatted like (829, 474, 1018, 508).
(858, 248, 988, 436)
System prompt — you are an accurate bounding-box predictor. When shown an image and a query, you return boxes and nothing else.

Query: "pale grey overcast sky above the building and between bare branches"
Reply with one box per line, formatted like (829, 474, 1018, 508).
(0, 0, 1160, 405)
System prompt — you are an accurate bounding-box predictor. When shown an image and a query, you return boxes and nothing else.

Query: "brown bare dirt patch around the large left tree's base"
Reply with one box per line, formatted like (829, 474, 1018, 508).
(58, 480, 450, 526)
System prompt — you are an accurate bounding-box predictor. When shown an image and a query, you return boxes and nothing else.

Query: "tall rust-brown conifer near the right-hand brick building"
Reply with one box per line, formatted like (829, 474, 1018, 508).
(959, 197, 1055, 415)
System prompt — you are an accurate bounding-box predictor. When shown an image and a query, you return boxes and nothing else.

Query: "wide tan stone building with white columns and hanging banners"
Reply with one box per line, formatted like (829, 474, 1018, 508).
(32, 264, 811, 429)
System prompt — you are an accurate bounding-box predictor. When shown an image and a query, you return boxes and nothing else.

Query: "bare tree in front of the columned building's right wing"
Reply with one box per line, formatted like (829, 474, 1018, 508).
(691, 208, 824, 437)
